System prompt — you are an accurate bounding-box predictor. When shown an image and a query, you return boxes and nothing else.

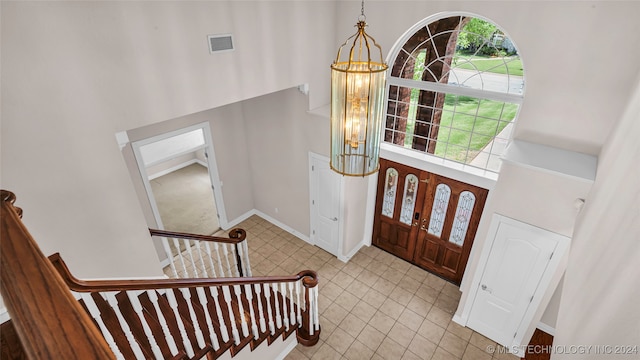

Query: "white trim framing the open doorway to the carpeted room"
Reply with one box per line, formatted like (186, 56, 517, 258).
(131, 122, 228, 229)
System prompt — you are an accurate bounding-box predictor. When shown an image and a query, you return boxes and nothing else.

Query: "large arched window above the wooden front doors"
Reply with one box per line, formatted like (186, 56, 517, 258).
(384, 13, 524, 173)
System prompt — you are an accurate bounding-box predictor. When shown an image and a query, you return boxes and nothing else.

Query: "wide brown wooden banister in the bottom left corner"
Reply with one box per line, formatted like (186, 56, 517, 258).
(0, 190, 115, 359)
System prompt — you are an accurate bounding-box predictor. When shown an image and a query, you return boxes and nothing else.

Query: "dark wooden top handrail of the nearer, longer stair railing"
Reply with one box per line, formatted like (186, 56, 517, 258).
(49, 253, 318, 292)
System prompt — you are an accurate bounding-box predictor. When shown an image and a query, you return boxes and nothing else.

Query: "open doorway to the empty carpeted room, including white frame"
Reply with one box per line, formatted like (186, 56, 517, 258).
(132, 123, 226, 235)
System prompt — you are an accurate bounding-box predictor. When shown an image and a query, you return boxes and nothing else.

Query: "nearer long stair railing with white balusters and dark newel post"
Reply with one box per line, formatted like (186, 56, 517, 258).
(49, 254, 320, 359)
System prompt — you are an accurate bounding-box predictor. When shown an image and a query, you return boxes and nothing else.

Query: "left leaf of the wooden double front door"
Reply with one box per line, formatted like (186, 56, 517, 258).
(373, 159, 428, 261)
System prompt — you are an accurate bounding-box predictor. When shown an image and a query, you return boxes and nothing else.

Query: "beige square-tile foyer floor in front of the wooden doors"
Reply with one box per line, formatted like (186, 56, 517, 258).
(220, 216, 518, 360)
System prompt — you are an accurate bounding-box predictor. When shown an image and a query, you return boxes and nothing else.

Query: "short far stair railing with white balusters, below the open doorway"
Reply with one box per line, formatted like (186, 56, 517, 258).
(149, 229, 252, 278)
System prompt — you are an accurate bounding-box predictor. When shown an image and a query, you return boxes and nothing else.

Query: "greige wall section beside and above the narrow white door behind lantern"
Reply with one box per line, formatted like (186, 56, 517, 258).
(242, 89, 329, 237)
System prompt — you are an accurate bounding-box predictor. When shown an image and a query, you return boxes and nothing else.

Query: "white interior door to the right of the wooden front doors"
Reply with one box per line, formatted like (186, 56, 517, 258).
(468, 217, 558, 345)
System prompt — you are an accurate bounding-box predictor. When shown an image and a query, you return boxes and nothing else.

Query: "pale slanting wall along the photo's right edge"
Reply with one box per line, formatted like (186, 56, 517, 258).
(552, 78, 640, 359)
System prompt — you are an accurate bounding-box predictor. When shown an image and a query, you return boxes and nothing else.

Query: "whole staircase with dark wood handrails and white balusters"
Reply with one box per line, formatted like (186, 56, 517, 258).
(1, 191, 320, 359)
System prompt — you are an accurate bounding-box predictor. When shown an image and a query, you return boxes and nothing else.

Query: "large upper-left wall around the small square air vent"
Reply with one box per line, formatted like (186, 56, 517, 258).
(0, 1, 335, 277)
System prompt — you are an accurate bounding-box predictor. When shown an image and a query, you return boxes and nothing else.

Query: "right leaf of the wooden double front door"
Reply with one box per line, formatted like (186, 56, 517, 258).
(414, 174, 488, 284)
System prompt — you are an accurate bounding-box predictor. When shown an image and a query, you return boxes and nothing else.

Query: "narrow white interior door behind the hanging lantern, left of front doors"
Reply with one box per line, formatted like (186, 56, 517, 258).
(309, 154, 342, 256)
